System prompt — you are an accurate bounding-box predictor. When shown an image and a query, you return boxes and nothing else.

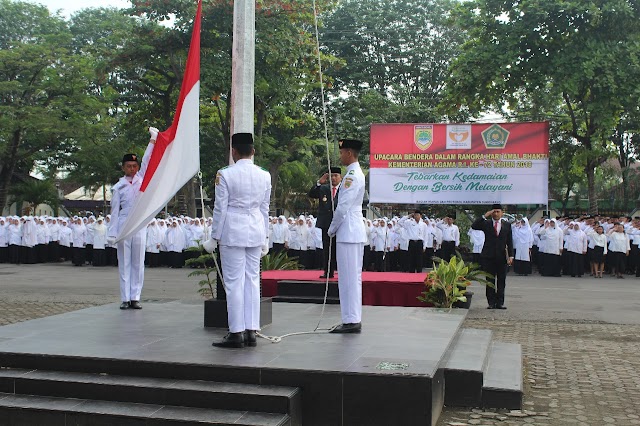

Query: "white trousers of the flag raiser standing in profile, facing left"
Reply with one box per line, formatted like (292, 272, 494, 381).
(336, 243, 364, 324)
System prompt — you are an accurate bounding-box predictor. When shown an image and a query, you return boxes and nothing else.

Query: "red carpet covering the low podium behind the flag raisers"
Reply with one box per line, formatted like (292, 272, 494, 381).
(262, 270, 427, 307)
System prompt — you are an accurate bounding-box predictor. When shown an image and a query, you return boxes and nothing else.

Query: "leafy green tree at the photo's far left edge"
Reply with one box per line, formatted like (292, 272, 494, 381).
(0, 0, 101, 213)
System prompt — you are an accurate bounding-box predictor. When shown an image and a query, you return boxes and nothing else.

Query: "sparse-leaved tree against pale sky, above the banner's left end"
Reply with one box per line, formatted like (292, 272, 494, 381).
(321, 0, 464, 145)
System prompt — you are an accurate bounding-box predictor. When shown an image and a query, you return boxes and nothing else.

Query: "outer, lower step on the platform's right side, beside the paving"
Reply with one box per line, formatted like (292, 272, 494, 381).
(482, 342, 523, 410)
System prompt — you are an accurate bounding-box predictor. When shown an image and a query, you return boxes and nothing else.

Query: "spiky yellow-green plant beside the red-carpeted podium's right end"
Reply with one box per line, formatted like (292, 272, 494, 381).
(418, 256, 495, 309)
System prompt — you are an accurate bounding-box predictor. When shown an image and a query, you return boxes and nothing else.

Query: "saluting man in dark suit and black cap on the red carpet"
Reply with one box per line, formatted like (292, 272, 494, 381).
(309, 167, 342, 278)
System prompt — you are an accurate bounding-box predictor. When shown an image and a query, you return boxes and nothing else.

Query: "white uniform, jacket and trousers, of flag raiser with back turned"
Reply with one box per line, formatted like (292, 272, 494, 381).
(211, 159, 271, 333)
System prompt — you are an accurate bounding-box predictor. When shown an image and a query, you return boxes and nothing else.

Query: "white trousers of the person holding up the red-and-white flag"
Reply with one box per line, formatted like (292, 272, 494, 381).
(117, 228, 147, 302)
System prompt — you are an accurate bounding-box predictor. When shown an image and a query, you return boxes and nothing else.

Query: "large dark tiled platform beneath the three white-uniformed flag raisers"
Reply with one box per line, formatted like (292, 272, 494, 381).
(0, 301, 522, 426)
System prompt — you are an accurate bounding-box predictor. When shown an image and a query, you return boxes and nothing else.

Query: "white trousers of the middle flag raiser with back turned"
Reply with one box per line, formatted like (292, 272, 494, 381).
(220, 245, 262, 333)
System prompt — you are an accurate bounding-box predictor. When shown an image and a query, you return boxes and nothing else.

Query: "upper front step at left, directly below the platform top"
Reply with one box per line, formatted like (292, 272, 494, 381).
(0, 369, 301, 422)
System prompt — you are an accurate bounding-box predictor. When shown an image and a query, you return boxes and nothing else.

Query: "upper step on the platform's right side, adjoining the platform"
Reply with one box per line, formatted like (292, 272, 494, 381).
(443, 328, 492, 407)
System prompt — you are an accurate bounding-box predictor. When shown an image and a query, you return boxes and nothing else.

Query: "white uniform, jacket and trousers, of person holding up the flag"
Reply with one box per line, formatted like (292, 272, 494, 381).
(108, 143, 154, 302)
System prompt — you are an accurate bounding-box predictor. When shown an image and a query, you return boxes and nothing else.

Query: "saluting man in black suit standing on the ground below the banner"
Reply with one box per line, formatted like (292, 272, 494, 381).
(471, 204, 513, 309)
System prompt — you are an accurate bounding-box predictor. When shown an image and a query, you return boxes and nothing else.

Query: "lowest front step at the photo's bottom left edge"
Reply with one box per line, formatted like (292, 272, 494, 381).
(0, 393, 293, 426)
